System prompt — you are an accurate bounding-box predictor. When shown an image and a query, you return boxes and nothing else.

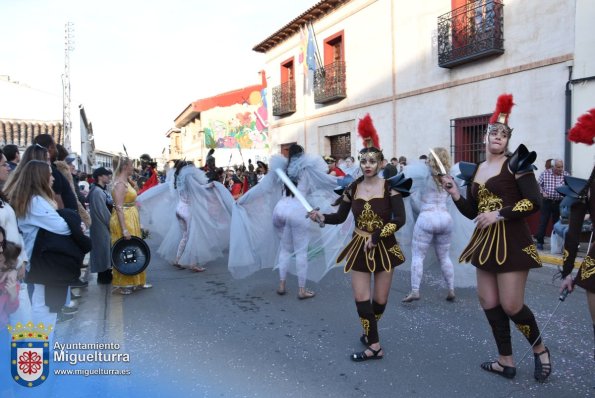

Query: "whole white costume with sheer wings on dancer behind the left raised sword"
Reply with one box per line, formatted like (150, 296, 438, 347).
(228, 154, 353, 283)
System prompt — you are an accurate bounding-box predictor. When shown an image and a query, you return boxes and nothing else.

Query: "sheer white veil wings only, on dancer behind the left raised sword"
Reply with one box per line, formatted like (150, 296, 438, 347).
(228, 154, 353, 282)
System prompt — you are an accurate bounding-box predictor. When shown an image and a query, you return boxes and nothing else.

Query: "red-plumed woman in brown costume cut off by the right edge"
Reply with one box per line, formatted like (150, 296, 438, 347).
(561, 108, 595, 357)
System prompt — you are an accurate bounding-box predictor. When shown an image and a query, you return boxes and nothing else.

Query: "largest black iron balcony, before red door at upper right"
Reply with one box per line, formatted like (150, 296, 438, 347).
(438, 0, 504, 68)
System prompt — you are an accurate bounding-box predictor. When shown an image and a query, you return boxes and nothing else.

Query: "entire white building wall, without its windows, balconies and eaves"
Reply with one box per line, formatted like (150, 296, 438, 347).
(266, 0, 595, 174)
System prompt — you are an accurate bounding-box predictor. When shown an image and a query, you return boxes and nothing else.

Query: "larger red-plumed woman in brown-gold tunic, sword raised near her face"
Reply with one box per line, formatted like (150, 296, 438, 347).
(443, 95, 552, 381)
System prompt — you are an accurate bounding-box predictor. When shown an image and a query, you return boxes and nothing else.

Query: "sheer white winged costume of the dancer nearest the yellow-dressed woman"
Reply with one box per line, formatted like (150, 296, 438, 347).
(137, 165, 234, 265)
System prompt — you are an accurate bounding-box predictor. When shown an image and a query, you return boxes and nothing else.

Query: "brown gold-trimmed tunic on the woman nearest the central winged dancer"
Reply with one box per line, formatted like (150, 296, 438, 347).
(324, 182, 405, 273)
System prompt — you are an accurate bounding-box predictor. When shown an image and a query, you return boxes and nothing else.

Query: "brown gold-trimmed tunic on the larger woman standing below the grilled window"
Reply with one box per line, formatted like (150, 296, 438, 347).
(455, 159, 541, 273)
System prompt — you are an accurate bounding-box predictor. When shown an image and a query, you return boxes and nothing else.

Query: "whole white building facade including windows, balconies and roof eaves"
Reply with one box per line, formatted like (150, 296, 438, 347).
(254, 0, 595, 177)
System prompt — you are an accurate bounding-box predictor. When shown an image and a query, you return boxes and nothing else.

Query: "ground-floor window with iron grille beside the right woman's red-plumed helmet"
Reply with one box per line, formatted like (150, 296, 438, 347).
(450, 114, 491, 163)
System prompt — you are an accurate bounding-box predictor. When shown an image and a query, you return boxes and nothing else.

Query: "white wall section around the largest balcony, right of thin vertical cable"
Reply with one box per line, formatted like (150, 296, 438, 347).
(394, 0, 574, 168)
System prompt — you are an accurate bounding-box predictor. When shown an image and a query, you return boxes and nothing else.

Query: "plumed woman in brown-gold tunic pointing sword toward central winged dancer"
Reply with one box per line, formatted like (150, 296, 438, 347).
(310, 115, 411, 362)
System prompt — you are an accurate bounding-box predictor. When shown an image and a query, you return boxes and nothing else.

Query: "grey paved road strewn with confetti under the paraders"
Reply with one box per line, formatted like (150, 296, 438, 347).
(4, 244, 595, 398)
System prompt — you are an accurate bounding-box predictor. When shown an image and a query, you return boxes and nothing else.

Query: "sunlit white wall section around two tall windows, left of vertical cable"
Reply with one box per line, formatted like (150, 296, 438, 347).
(266, 0, 393, 159)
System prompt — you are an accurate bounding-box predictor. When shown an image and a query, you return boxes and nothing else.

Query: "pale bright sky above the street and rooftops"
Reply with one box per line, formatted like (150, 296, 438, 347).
(0, 0, 318, 156)
